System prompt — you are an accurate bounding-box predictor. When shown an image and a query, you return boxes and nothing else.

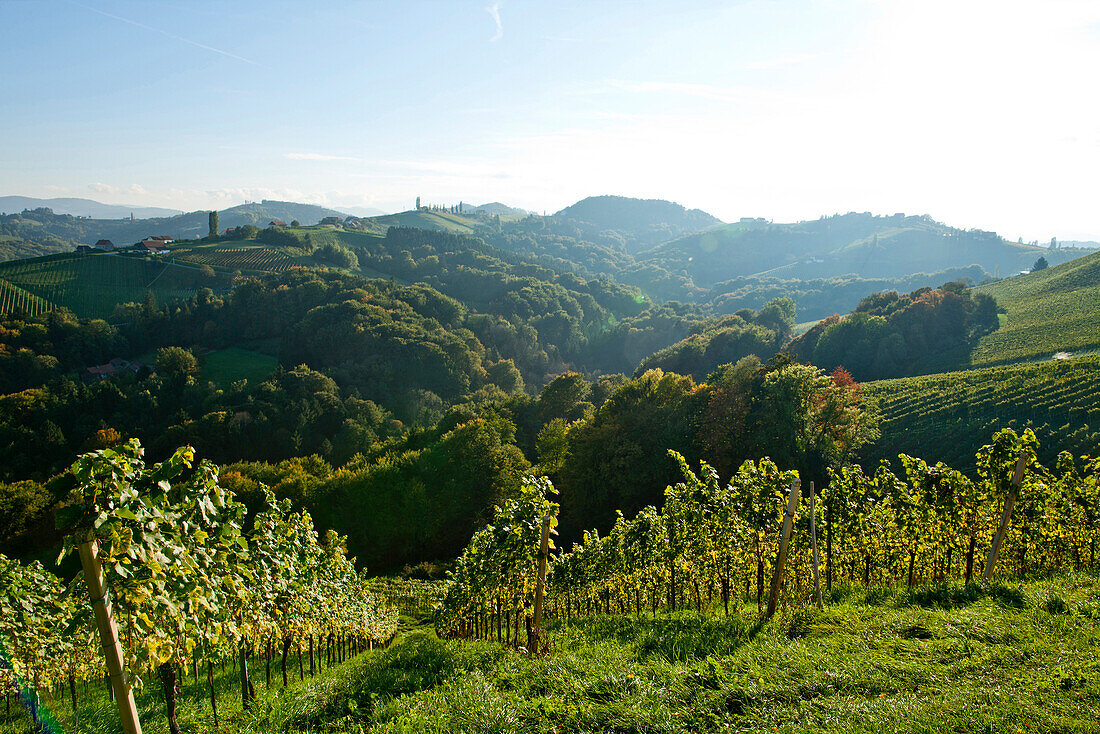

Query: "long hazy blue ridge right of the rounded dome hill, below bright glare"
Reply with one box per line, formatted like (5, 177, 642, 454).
(637, 213, 1081, 287)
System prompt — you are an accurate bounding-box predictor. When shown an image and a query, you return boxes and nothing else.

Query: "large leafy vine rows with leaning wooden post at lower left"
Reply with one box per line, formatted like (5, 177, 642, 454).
(0, 440, 397, 734)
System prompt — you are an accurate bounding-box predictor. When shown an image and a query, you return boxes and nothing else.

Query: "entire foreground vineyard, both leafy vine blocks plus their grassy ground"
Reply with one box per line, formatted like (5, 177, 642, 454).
(0, 430, 1100, 733)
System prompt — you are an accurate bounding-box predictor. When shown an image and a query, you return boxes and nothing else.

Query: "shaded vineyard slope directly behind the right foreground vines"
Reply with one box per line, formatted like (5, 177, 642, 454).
(864, 357, 1100, 465)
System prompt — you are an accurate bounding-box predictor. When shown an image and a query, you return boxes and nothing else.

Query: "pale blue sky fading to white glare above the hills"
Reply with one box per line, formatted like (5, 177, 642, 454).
(0, 0, 1100, 242)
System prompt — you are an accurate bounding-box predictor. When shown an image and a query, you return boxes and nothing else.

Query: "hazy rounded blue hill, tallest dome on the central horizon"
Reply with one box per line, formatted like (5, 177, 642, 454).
(553, 196, 722, 252)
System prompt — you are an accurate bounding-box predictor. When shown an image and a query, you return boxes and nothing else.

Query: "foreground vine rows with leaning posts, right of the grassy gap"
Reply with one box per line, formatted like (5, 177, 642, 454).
(437, 429, 1100, 650)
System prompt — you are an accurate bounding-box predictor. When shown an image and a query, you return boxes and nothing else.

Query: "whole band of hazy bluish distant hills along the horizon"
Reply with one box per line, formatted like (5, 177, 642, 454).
(0, 196, 1088, 321)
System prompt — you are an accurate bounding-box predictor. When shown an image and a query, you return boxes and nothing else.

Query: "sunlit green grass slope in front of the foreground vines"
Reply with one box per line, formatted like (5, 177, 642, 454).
(10, 573, 1100, 734)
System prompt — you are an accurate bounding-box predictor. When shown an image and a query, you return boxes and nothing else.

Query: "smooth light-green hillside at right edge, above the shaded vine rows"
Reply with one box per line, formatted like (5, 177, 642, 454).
(971, 252, 1100, 365)
